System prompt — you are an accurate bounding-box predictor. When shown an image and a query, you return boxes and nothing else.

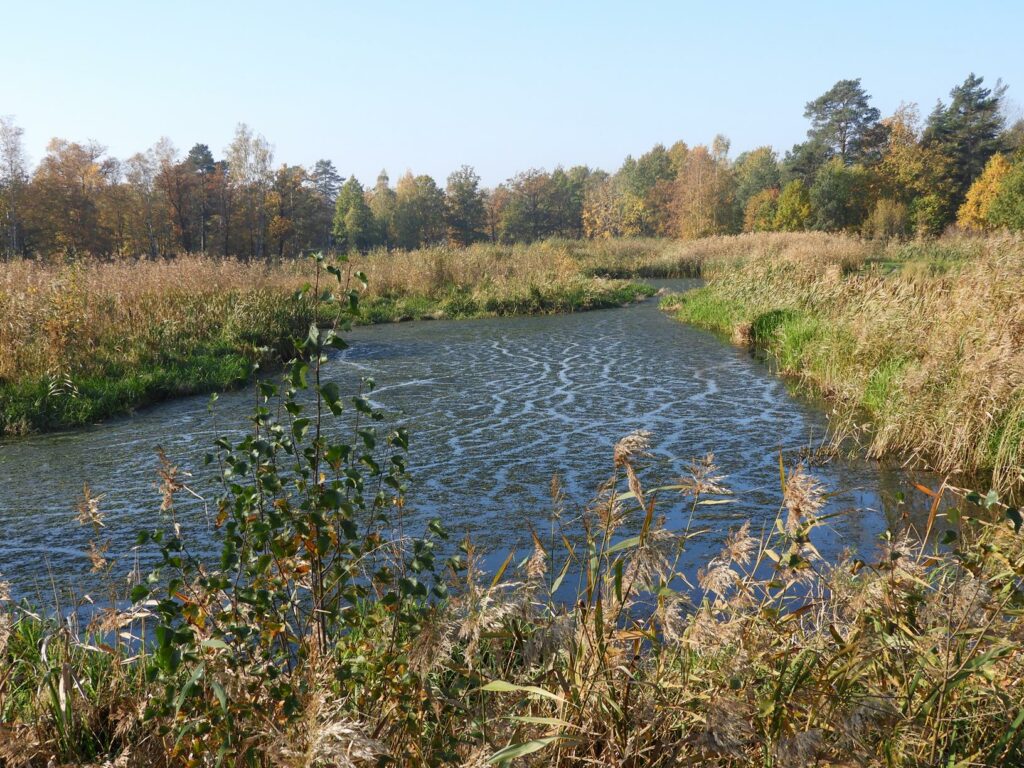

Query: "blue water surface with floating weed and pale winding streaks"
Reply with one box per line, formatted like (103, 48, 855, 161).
(0, 281, 929, 601)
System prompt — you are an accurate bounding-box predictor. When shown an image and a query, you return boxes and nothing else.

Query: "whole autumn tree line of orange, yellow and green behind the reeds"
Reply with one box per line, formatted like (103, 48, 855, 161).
(0, 74, 1024, 258)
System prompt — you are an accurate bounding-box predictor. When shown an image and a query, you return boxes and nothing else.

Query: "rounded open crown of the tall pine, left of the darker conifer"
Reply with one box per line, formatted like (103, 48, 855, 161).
(804, 78, 880, 165)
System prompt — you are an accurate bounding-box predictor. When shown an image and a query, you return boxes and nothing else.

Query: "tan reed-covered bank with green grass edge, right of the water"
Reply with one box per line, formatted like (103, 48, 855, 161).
(665, 233, 1024, 487)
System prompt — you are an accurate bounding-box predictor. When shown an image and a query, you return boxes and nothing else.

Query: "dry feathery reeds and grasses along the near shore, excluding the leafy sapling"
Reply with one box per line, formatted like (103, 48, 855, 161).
(0, 433, 1024, 767)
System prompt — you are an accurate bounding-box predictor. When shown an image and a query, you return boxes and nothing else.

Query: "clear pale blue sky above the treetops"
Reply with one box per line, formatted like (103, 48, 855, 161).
(0, 0, 1024, 184)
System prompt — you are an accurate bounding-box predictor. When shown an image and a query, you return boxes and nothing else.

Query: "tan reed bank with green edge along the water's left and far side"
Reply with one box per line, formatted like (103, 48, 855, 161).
(0, 241, 690, 434)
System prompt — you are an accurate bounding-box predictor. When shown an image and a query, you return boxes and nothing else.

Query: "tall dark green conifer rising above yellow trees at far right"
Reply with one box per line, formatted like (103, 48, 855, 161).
(923, 73, 1007, 222)
